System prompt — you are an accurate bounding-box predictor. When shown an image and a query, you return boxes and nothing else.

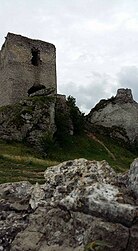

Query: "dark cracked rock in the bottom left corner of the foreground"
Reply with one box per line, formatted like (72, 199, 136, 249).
(0, 182, 31, 251)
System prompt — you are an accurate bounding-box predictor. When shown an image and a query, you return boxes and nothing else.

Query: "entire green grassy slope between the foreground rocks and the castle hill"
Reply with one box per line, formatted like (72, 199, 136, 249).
(0, 135, 136, 183)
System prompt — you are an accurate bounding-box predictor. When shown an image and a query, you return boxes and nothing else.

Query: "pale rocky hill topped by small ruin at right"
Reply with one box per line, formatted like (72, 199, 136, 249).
(87, 89, 138, 147)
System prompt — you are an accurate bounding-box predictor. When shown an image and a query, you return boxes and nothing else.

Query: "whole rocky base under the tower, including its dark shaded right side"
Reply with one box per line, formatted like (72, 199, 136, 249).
(0, 94, 76, 149)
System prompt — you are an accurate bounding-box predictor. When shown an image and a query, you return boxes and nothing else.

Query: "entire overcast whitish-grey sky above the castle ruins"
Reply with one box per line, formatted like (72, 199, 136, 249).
(0, 0, 138, 112)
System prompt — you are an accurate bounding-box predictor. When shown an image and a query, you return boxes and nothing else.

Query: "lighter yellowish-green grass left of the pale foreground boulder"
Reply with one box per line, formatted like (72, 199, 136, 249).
(0, 141, 58, 184)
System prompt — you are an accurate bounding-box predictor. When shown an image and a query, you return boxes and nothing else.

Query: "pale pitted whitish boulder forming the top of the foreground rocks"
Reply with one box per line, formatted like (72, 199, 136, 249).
(30, 159, 136, 225)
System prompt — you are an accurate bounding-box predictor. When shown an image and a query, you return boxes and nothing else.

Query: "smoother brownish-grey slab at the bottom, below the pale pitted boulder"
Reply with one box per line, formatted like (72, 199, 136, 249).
(11, 207, 128, 251)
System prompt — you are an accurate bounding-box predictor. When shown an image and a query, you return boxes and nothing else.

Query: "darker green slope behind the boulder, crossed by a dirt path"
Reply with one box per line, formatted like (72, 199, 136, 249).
(44, 135, 136, 172)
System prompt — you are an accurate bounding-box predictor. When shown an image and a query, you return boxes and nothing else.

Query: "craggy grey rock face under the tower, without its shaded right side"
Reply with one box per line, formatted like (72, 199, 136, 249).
(0, 96, 56, 146)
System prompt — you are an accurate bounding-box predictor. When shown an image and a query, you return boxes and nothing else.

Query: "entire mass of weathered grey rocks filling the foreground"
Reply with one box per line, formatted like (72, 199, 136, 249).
(0, 159, 138, 251)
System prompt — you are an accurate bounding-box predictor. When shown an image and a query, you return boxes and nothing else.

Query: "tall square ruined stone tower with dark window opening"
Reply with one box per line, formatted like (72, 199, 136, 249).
(0, 33, 57, 106)
